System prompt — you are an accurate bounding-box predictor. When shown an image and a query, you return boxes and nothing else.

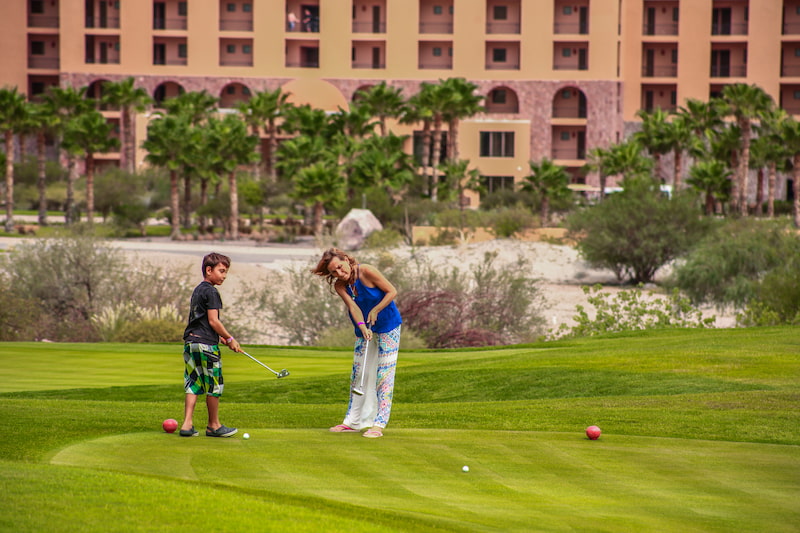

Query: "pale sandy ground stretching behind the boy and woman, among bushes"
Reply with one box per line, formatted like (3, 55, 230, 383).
(0, 234, 735, 344)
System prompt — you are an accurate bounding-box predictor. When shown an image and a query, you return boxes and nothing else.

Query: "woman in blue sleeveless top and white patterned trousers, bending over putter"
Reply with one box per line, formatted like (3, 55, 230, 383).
(312, 248, 403, 438)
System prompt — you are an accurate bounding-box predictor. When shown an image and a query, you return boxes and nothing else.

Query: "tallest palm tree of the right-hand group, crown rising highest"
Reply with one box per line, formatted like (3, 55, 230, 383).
(722, 83, 775, 216)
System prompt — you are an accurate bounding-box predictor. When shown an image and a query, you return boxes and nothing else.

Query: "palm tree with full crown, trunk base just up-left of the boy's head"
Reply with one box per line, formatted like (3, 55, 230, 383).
(142, 114, 192, 240)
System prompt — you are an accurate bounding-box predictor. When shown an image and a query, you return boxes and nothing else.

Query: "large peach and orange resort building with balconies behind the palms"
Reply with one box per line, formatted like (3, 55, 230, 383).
(0, 0, 800, 206)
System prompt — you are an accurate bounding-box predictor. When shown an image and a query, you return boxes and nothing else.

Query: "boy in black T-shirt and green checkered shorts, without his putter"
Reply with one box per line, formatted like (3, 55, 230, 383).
(179, 253, 242, 437)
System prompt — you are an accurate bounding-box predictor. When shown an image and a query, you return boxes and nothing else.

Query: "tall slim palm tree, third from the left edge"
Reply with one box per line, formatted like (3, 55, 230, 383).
(43, 87, 94, 226)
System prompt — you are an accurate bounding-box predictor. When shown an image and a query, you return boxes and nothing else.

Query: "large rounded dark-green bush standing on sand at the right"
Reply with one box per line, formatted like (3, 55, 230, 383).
(567, 178, 708, 284)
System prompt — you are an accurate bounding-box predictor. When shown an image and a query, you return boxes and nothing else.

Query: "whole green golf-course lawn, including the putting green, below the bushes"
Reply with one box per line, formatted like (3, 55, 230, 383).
(0, 328, 800, 531)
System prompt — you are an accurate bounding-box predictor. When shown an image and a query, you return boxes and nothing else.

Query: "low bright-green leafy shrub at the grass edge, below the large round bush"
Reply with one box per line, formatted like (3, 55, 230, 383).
(548, 285, 715, 339)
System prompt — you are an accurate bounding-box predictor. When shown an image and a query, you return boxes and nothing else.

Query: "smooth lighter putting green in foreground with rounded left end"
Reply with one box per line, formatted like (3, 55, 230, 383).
(52, 428, 800, 531)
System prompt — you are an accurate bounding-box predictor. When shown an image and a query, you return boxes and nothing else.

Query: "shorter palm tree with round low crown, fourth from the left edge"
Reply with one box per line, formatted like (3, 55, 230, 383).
(64, 110, 119, 225)
